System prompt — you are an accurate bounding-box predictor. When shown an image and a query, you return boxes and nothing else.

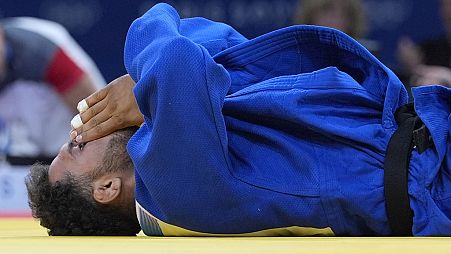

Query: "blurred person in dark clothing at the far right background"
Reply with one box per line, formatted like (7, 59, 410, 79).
(398, 0, 451, 87)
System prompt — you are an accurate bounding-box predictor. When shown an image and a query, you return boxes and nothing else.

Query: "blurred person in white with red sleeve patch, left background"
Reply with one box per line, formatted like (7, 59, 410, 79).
(0, 17, 105, 164)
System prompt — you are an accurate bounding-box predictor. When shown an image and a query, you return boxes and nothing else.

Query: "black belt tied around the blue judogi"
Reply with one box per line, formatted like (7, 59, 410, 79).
(384, 103, 432, 236)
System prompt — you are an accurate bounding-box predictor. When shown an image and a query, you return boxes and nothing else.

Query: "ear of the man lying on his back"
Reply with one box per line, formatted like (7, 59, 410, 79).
(93, 177, 122, 204)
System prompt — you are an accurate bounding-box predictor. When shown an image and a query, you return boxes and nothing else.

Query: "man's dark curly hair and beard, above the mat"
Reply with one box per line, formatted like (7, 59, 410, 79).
(25, 128, 141, 236)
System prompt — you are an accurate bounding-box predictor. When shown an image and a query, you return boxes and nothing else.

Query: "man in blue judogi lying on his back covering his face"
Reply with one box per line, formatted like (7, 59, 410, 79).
(27, 4, 451, 236)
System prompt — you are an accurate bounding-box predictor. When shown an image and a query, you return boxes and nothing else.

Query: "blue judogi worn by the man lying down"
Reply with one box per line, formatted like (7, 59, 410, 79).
(125, 4, 451, 235)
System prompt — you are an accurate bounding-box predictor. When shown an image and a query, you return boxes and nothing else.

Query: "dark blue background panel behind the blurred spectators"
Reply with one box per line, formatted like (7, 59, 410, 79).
(0, 0, 443, 80)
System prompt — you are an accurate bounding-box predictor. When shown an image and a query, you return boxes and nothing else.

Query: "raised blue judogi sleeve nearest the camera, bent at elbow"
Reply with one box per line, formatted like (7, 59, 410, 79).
(125, 4, 238, 230)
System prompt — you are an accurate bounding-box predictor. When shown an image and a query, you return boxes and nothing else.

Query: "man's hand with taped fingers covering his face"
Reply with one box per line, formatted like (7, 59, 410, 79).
(70, 75, 144, 143)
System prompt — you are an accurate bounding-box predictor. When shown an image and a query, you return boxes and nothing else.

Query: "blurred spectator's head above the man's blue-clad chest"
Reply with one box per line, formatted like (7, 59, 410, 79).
(294, 0, 379, 55)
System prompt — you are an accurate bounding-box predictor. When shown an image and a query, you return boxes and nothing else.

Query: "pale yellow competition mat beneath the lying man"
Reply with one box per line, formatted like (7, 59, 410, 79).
(0, 218, 451, 254)
